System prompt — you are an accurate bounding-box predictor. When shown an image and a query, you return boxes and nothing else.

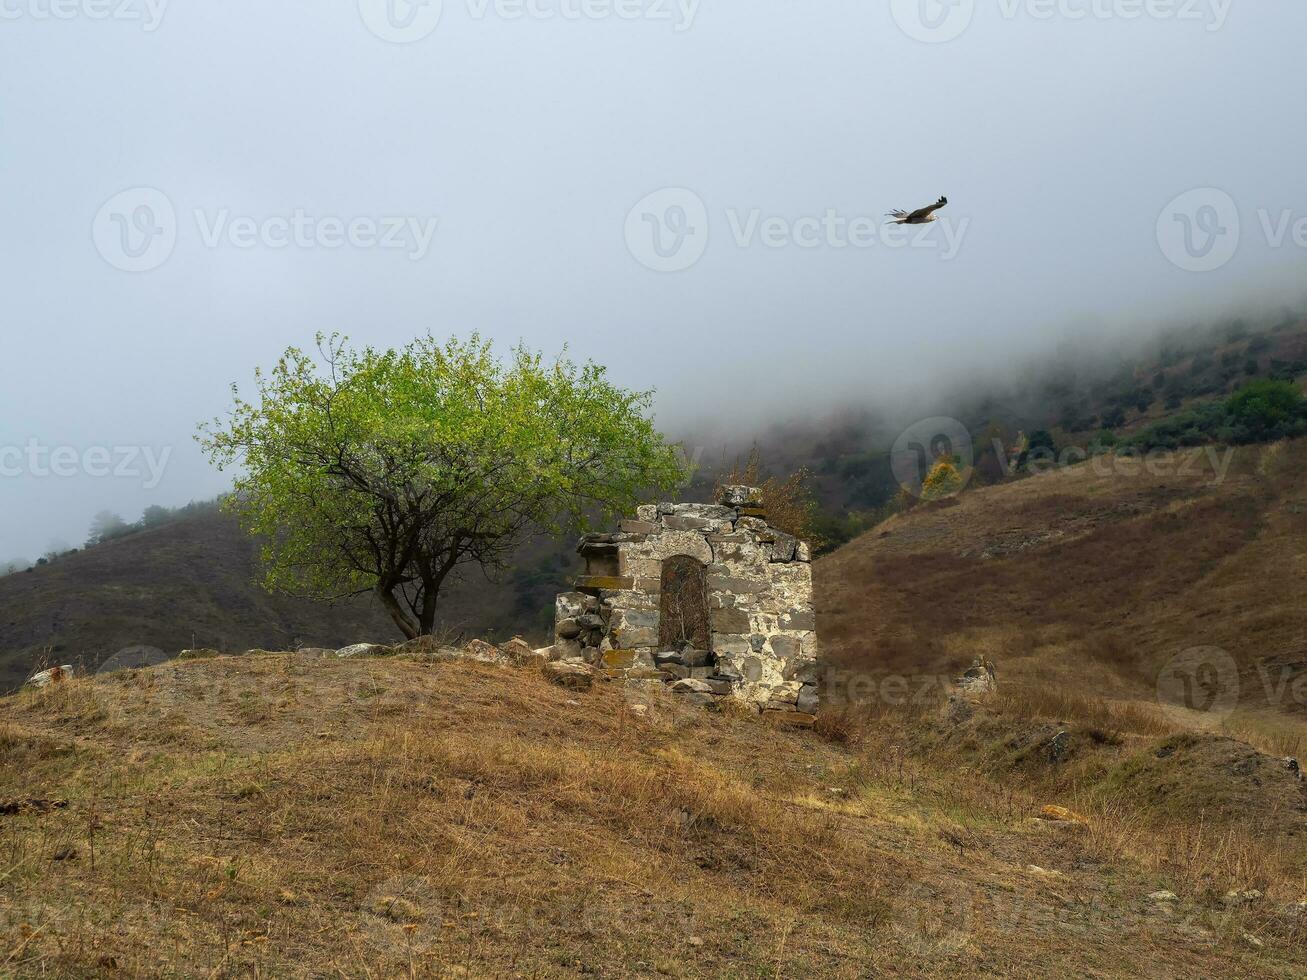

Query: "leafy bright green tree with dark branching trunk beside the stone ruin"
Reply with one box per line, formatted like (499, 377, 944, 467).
(199, 335, 687, 636)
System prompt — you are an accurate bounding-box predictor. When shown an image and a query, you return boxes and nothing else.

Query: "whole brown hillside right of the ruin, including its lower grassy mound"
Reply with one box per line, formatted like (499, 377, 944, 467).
(816, 440, 1307, 883)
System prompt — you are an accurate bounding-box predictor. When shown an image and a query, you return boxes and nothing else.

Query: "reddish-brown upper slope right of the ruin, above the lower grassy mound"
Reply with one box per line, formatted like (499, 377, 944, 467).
(816, 440, 1307, 749)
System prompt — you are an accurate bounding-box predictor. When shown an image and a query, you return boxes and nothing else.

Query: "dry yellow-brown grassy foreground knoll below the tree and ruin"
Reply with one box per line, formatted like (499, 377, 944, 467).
(0, 656, 1304, 977)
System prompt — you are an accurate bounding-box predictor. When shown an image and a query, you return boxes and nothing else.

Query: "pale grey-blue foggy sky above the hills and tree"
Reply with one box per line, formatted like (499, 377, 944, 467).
(0, 0, 1307, 558)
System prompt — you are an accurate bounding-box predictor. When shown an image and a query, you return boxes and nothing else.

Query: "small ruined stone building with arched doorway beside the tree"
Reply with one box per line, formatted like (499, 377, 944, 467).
(552, 486, 818, 720)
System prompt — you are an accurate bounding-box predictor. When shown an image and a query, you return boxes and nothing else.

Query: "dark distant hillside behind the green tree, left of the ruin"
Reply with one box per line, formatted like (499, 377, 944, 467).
(0, 512, 563, 691)
